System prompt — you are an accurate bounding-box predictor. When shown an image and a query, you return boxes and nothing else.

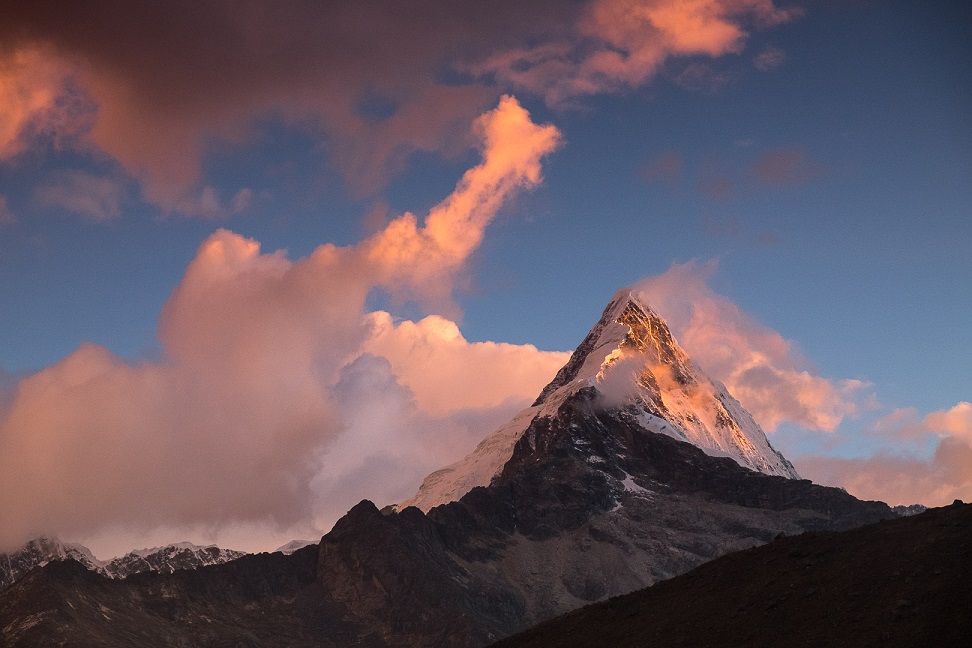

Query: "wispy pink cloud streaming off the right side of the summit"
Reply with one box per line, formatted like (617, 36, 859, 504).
(636, 262, 867, 431)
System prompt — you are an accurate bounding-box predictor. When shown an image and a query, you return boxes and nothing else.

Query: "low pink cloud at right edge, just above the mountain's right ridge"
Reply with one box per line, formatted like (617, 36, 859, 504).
(796, 401, 972, 506)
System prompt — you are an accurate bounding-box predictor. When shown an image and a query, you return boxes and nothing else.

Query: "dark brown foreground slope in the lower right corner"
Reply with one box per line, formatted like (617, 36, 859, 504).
(494, 503, 972, 648)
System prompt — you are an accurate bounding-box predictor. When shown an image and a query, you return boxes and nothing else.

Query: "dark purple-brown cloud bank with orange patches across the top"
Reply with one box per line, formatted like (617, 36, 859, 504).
(0, 0, 796, 217)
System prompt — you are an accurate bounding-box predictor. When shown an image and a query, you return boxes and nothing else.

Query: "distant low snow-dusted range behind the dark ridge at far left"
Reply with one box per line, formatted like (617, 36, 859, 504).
(0, 537, 246, 591)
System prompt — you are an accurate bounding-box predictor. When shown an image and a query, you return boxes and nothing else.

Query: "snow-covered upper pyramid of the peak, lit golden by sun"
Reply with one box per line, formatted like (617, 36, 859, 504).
(395, 288, 799, 511)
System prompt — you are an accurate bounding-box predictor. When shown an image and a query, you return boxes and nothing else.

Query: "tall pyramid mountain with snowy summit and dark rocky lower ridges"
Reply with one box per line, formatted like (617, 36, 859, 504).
(0, 290, 897, 648)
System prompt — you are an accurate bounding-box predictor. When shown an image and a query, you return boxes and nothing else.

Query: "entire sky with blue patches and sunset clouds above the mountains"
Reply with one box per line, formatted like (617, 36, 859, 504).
(0, 0, 972, 558)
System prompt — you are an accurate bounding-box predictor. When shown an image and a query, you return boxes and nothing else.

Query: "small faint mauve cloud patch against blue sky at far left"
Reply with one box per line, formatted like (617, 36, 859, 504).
(33, 171, 125, 221)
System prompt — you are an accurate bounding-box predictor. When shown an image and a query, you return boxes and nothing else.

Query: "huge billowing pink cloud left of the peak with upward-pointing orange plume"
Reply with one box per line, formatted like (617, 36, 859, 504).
(0, 98, 563, 546)
